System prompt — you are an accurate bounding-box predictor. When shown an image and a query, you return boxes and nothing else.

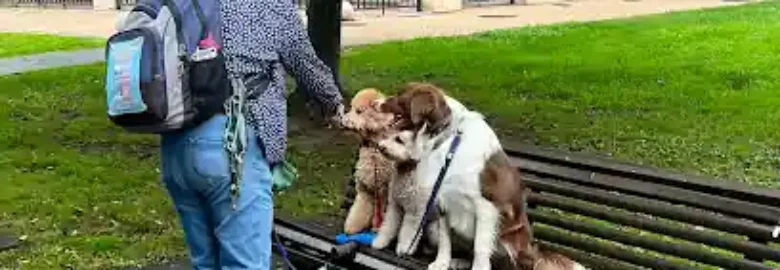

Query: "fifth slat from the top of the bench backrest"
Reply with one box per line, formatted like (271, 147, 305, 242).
(528, 210, 772, 270)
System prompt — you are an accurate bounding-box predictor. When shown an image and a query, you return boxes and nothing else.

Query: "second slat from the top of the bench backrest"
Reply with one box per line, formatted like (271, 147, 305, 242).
(512, 159, 780, 225)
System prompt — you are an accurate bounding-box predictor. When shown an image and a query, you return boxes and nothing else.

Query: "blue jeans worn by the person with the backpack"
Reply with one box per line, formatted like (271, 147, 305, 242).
(161, 115, 273, 270)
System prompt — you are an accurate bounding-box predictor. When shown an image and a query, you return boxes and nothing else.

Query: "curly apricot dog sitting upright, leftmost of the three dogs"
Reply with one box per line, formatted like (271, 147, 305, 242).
(341, 88, 396, 234)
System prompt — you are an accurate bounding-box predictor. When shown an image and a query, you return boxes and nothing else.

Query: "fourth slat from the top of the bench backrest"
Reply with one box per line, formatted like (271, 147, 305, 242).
(529, 193, 780, 262)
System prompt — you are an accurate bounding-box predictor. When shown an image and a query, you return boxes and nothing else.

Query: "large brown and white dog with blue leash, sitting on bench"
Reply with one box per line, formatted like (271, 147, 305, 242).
(376, 83, 584, 270)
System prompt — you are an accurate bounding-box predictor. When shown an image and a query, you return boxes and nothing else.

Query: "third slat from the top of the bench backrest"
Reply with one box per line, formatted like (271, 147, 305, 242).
(521, 173, 778, 241)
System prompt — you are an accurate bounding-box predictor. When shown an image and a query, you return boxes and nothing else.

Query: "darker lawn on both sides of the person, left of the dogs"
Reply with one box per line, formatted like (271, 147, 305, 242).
(0, 64, 353, 269)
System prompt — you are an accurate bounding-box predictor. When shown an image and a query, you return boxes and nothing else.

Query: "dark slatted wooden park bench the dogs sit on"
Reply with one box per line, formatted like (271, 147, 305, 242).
(276, 146, 780, 270)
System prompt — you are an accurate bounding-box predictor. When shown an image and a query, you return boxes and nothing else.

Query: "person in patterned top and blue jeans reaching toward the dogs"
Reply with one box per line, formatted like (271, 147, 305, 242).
(161, 0, 344, 270)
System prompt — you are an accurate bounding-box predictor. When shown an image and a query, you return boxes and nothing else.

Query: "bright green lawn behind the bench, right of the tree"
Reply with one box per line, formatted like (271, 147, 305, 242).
(343, 1, 780, 187)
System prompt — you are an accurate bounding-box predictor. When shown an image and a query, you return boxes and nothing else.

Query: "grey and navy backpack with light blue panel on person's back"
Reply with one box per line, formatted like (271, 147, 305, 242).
(105, 0, 232, 134)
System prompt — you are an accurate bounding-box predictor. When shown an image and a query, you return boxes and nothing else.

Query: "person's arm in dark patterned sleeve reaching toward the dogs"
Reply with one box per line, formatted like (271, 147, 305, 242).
(278, 0, 343, 116)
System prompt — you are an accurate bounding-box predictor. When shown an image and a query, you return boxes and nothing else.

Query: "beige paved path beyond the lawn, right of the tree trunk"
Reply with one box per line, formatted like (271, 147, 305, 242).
(342, 0, 740, 45)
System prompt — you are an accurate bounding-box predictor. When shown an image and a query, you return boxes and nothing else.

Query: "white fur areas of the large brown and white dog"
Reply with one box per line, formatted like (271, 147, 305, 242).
(380, 97, 502, 270)
